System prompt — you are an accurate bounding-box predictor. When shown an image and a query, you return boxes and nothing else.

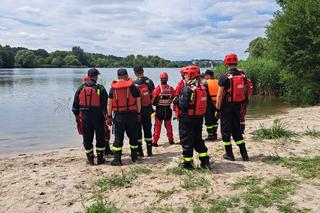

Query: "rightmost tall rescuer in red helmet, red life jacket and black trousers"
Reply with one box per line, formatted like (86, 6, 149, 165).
(216, 53, 249, 161)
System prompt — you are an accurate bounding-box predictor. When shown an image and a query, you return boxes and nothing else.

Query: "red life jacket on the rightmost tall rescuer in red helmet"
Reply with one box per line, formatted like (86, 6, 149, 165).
(226, 73, 247, 103)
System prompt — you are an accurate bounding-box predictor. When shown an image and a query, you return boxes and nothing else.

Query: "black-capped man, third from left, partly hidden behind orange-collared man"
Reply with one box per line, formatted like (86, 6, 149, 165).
(133, 65, 154, 157)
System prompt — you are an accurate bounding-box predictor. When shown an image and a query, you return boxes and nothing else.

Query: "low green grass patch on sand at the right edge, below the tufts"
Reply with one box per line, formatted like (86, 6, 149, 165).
(263, 156, 320, 179)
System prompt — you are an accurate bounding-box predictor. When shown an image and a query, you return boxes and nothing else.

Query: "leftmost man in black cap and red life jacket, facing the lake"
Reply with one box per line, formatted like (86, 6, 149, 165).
(72, 68, 108, 165)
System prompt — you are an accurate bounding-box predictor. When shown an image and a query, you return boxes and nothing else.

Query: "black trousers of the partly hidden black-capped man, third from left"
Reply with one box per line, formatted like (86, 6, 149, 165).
(138, 106, 152, 143)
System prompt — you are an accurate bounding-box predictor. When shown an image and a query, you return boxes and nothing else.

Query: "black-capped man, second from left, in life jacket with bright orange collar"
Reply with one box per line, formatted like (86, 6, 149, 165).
(107, 69, 141, 166)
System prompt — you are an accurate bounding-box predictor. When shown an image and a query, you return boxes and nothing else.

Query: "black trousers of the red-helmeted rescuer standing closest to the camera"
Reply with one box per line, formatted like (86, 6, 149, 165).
(179, 116, 208, 161)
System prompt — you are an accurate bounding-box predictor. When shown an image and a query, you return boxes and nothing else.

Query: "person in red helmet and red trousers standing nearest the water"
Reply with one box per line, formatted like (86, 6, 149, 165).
(152, 72, 175, 147)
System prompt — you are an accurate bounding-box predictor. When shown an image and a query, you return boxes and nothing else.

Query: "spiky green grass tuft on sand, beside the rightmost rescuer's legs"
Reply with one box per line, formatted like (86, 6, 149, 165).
(253, 120, 297, 140)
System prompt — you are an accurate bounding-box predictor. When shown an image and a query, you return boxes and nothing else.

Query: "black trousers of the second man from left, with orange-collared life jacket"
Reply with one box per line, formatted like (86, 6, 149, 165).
(112, 112, 138, 151)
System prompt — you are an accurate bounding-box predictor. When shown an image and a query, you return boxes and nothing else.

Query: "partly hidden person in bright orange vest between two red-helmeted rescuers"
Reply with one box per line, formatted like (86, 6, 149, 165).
(204, 70, 219, 141)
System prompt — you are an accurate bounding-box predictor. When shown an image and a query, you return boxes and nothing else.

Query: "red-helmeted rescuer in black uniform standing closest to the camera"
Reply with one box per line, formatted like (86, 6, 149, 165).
(177, 66, 210, 169)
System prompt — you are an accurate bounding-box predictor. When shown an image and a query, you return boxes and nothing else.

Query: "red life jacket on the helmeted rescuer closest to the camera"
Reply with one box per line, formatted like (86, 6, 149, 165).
(188, 84, 207, 116)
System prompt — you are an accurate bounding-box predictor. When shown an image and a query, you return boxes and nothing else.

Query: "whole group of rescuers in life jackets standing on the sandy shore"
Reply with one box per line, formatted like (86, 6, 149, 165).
(72, 53, 252, 169)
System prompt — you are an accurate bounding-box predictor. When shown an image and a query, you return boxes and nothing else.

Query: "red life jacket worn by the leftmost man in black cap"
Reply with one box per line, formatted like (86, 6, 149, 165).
(79, 83, 100, 108)
